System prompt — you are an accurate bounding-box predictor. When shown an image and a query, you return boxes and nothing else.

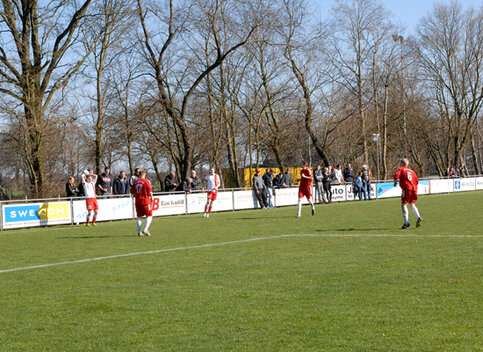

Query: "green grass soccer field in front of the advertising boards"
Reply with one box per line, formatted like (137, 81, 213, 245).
(0, 192, 483, 352)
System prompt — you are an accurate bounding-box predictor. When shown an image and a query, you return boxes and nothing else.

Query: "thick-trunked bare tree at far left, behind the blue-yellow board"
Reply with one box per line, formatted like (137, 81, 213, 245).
(0, 0, 92, 198)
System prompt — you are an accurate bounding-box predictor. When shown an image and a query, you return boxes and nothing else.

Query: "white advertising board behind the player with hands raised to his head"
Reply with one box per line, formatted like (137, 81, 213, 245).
(72, 197, 134, 224)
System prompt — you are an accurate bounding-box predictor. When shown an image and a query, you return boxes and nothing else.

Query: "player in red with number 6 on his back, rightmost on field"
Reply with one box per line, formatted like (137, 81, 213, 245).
(394, 158, 423, 229)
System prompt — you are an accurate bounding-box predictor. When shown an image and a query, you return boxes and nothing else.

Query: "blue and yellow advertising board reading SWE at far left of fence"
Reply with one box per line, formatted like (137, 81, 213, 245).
(2, 202, 71, 229)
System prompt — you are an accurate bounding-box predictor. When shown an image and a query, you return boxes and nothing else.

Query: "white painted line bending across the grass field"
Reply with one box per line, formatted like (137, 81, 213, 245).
(0, 234, 483, 274)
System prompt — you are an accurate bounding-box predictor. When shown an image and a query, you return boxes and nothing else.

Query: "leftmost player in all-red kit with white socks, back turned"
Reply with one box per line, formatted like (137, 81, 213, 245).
(131, 170, 153, 236)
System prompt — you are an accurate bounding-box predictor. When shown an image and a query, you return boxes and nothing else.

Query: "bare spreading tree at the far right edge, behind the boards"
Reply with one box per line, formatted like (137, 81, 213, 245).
(418, 1, 483, 171)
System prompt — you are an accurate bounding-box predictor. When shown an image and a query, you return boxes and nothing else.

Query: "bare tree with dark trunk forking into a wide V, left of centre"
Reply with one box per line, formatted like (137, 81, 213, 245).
(137, 0, 256, 182)
